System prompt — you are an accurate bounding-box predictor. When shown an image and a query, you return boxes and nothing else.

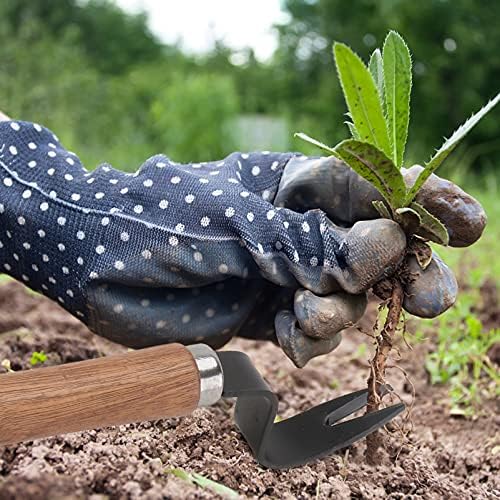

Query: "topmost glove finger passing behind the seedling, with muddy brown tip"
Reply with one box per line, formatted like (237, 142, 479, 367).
(274, 157, 487, 247)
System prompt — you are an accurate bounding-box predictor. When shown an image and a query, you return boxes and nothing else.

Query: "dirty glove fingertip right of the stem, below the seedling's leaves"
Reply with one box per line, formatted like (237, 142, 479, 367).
(403, 253, 458, 318)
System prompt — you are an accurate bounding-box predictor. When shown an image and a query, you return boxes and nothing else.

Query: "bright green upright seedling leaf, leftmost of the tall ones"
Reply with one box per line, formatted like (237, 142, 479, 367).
(333, 42, 391, 155)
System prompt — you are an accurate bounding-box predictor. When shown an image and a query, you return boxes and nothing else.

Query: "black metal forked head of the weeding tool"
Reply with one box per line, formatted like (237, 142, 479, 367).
(218, 351, 405, 469)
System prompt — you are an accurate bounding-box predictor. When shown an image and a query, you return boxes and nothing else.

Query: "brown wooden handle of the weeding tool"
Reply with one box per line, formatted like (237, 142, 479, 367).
(0, 344, 200, 445)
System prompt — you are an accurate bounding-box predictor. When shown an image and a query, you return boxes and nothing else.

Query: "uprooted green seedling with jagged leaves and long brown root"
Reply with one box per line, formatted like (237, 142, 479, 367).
(296, 31, 500, 462)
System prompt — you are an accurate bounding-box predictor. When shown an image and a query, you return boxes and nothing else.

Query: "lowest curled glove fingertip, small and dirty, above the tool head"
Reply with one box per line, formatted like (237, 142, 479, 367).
(275, 310, 342, 368)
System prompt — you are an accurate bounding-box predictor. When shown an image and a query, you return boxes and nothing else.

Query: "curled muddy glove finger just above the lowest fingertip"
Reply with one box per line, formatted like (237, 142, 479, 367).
(294, 289, 367, 339)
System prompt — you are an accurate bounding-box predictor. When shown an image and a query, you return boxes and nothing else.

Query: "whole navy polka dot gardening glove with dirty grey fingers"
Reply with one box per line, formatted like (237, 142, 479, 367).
(0, 121, 485, 366)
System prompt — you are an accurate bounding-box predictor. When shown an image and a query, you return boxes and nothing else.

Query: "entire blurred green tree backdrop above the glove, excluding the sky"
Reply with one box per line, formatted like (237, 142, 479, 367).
(0, 0, 500, 178)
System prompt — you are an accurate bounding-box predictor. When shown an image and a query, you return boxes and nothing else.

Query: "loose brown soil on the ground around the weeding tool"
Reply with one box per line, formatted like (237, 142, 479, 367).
(0, 282, 500, 500)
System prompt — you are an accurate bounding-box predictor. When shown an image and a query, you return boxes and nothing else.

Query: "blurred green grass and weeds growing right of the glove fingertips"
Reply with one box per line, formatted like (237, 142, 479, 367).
(415, 186, 500, 417)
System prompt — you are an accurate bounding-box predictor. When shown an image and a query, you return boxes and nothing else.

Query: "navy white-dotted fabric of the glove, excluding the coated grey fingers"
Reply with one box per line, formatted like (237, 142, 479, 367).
(0, 121, 342, 347)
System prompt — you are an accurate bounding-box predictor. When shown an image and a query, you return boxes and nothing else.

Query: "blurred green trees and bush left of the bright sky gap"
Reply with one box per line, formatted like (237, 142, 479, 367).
(0, 0, 237, 170)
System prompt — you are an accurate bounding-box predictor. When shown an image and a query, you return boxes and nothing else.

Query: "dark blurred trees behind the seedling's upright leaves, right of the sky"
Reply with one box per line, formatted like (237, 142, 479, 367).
(274, 0, 500, 172)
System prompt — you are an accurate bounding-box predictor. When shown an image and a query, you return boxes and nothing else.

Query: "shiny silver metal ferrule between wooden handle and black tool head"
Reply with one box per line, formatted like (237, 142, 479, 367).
(188, 344, 224, 407)
